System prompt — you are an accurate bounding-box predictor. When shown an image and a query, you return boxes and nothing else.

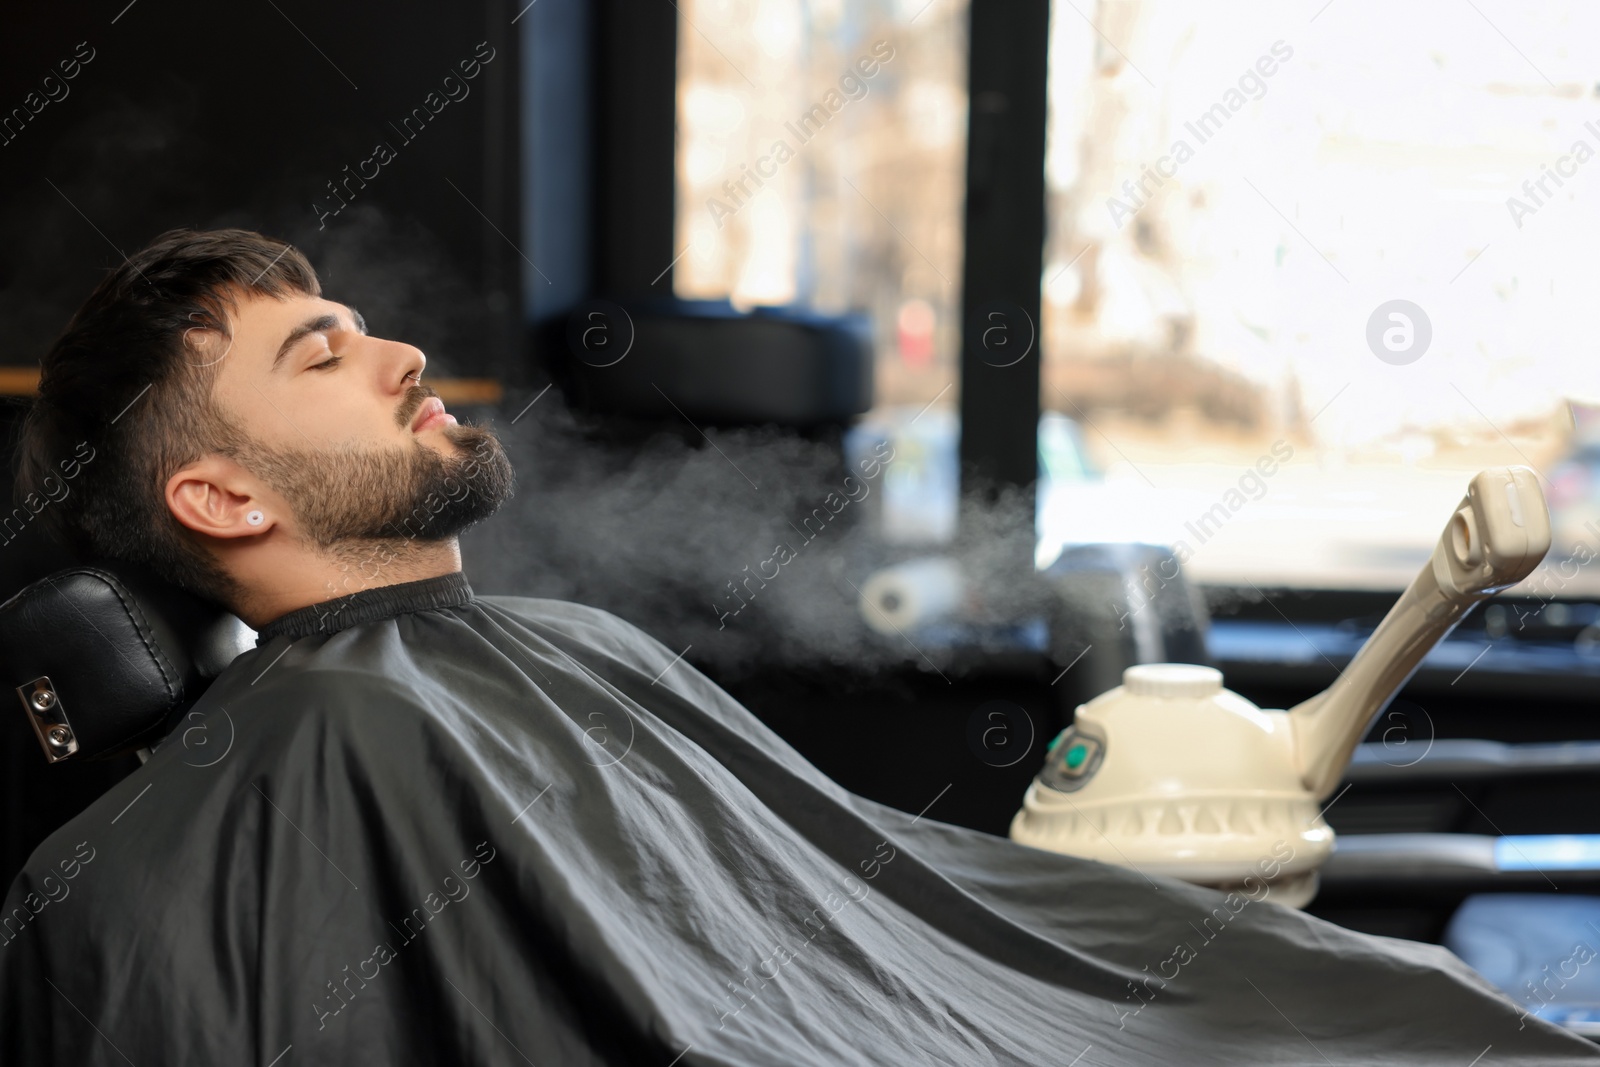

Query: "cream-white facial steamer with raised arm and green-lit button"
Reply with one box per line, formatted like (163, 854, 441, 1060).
(1011, 467, 1550, 907)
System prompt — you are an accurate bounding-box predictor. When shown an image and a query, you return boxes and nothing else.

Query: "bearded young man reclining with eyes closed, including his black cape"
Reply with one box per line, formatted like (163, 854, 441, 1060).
(0, 230, 1594, 1067)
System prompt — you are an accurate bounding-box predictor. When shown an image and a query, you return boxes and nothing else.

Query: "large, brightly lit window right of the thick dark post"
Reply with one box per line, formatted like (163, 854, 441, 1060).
(1042, 0, 1600, 592)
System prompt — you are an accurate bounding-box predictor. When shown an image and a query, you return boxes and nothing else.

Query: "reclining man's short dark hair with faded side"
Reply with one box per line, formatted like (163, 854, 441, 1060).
(16, 230, 322, 605)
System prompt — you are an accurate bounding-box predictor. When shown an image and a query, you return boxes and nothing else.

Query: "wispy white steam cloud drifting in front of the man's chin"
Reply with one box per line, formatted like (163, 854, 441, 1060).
(462, 399, 1048, 677)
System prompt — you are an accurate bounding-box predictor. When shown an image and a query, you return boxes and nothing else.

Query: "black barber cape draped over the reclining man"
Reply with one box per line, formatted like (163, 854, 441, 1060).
(0, 573, 1595, 1067)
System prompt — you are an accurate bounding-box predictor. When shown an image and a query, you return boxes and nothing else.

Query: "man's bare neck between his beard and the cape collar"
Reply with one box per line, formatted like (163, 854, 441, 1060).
(234, 537, 461, 630)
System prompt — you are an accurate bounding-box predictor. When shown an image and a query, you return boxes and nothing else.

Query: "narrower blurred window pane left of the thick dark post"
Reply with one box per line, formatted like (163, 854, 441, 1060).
(674, 0, 966, 541)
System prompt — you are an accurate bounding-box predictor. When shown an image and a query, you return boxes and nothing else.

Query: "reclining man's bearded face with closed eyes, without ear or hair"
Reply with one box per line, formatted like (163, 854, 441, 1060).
(196, 287, 512, 549)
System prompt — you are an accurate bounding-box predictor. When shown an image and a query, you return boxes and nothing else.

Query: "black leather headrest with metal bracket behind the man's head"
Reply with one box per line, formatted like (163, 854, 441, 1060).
(0, 560, 256, 763)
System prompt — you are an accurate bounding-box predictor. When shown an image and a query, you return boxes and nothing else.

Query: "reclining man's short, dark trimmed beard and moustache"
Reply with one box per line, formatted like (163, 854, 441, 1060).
(238, 386, 514, 558)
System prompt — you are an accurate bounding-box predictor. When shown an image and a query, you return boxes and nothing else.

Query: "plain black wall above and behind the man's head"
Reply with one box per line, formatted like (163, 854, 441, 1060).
(0, 0, 520, 385)
